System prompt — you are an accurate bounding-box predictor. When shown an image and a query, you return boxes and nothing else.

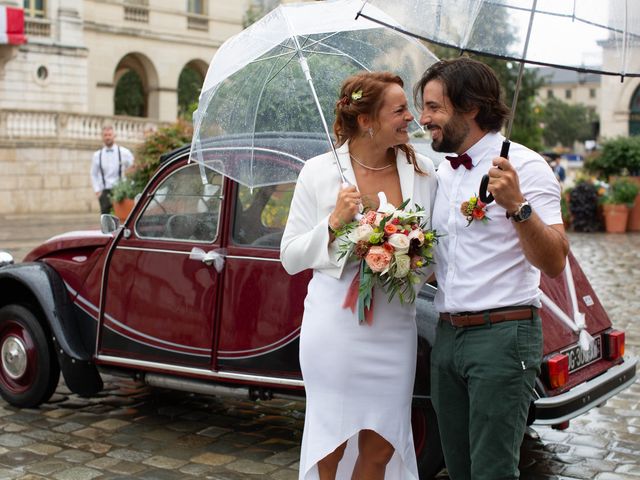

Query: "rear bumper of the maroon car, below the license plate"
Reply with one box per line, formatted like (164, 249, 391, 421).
(534, 357, 638, 425)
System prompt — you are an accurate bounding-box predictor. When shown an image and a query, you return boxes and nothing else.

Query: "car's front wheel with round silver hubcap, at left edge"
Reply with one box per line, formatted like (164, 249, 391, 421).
(0, 305, 60, 408)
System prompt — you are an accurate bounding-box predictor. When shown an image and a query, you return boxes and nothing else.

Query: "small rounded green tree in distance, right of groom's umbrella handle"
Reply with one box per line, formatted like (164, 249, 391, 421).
(541, 98, 594, 147)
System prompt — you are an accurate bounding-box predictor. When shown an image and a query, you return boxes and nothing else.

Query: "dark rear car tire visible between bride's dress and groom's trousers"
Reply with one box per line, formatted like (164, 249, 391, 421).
(411, 399, 444, 480)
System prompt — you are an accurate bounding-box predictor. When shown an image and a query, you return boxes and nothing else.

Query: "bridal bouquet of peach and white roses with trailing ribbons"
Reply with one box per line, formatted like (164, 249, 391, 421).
(336, 200, 438, 324)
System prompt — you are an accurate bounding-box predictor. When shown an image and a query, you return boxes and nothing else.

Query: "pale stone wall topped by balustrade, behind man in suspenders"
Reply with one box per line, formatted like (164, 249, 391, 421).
(0, 111, 157, 214)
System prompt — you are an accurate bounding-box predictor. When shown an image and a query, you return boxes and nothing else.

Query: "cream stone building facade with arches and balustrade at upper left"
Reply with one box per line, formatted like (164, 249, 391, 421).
(0, 0, 250, 214)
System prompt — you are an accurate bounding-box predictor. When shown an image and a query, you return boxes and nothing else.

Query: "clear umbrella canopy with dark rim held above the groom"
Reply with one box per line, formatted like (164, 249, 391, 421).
(361, 0, 640, 77)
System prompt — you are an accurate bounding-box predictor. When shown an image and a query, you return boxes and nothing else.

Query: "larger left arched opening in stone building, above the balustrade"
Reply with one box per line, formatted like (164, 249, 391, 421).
(113, 53, 158, 117)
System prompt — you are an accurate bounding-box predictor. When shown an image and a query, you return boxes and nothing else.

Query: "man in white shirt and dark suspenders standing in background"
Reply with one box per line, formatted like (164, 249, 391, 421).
(91, 125, 133, 213)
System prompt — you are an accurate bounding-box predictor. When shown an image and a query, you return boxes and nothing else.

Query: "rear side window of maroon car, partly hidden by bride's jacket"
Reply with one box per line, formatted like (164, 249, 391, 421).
(233, 183, 295, 248)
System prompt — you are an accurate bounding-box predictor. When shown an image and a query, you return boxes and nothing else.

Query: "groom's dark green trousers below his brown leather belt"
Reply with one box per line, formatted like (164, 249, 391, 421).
(431, 315, 542, 480)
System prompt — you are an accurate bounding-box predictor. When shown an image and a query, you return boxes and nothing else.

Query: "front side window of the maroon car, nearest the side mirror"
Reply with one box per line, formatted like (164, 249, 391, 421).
(135, 163, 223, 243)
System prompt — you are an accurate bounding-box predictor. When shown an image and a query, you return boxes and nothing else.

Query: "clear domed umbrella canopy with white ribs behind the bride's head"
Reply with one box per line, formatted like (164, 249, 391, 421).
(191, 0, 437, 187)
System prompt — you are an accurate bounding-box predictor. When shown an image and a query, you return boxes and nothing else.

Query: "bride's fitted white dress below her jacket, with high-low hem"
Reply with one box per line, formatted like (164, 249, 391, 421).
(299, 262, 418, 480)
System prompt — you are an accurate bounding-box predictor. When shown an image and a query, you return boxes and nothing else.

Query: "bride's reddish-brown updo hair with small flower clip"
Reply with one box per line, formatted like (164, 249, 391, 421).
(333, 72, 423, 173)
